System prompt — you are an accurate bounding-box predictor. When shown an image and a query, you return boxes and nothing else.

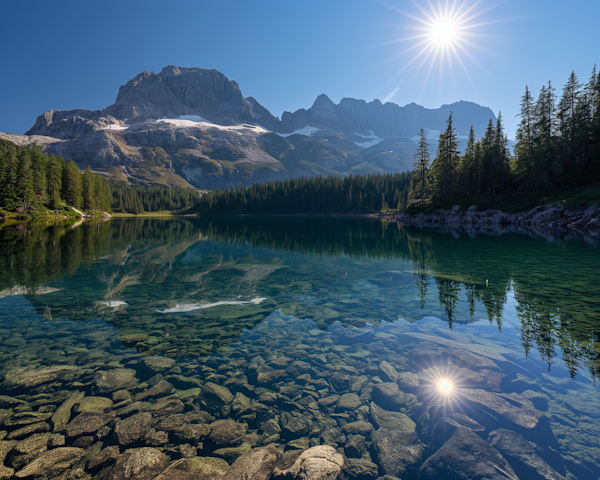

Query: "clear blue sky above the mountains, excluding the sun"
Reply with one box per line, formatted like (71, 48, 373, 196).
(0, 0, 600, 138)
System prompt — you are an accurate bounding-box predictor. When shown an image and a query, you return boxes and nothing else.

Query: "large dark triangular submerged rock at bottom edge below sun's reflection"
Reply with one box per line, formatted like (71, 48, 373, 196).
(419, 428, 518, 480)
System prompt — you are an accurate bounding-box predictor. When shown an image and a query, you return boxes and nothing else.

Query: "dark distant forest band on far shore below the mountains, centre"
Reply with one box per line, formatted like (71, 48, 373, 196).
(195, 172, 411, 214)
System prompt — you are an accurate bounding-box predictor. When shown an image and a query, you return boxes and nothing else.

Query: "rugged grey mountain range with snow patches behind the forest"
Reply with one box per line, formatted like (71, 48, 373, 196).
(0, 66, 496, 188)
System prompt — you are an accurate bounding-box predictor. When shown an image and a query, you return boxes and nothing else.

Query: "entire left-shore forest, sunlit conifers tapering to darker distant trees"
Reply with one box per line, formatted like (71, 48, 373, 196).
(0, 140, 199, 215)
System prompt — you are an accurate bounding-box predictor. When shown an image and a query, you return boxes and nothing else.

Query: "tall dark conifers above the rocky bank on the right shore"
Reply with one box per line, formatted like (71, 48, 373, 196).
(410, 66, 600, 203)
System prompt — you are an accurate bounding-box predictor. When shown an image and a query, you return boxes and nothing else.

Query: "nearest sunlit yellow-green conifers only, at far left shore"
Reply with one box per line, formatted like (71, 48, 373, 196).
(0, 140, 111, 213)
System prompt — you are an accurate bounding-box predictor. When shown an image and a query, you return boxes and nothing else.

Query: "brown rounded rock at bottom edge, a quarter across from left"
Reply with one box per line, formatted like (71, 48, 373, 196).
(105, 447, 171, 480)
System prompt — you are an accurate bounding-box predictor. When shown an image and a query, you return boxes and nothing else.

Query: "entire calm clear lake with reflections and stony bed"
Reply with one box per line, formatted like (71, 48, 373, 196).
(0, 217, 600, 480)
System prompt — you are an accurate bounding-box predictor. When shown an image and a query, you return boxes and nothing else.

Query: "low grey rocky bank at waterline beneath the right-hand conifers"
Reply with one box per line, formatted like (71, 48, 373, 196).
(397, 204, 600, 234)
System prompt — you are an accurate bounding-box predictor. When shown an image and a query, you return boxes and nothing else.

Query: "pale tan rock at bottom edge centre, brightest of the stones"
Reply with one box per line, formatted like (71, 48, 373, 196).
(272, 445, 348, 480)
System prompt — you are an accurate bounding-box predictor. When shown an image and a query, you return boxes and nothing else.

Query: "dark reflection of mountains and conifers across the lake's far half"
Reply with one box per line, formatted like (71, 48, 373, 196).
(0, 217, 600, 377)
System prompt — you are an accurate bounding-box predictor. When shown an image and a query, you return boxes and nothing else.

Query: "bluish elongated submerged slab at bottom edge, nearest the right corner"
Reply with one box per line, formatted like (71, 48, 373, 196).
(488, 429, 565, 480)
